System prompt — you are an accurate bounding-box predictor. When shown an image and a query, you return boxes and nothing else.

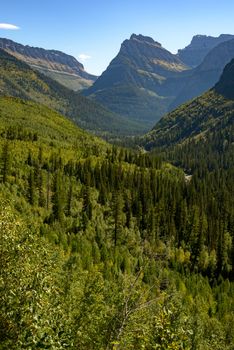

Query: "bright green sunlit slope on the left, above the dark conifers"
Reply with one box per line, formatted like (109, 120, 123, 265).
(0, 97, 107, 152)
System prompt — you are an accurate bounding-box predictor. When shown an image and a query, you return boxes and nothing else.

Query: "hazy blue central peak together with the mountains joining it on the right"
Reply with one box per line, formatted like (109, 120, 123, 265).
(84, 34, 234, 128)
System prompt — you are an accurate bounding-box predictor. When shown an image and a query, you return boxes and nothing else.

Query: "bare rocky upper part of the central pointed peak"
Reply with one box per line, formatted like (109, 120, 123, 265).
(89, 34, 187, 93)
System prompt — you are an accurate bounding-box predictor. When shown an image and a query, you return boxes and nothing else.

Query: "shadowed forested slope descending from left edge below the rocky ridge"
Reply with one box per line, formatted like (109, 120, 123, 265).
(0, 49, 142, 136)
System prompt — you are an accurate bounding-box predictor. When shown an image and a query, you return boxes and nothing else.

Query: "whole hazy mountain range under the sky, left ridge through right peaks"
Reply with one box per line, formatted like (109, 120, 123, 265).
(0, 34, 234, 135)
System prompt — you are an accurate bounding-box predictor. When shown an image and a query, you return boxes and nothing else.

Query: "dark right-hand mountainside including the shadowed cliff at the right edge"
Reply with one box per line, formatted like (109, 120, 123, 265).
(142, 59, 234, 153)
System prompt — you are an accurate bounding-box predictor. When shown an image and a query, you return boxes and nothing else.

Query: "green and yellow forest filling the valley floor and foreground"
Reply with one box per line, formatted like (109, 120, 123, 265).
(0, 97, 234, 350)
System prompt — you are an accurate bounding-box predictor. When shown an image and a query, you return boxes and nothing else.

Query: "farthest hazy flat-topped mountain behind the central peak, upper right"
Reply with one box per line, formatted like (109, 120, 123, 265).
(177, 34, 234, 67)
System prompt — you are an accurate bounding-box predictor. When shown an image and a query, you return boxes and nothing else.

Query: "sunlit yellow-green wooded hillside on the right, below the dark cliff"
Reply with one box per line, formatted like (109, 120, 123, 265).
(142, 90, 234, 149)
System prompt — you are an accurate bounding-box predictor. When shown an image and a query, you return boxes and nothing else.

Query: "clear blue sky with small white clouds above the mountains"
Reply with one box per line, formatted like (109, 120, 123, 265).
(0, 0, 234, 75)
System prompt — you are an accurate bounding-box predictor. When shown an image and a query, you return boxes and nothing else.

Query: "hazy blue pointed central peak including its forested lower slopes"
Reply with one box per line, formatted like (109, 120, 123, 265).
(84, 34, 188, 127)
